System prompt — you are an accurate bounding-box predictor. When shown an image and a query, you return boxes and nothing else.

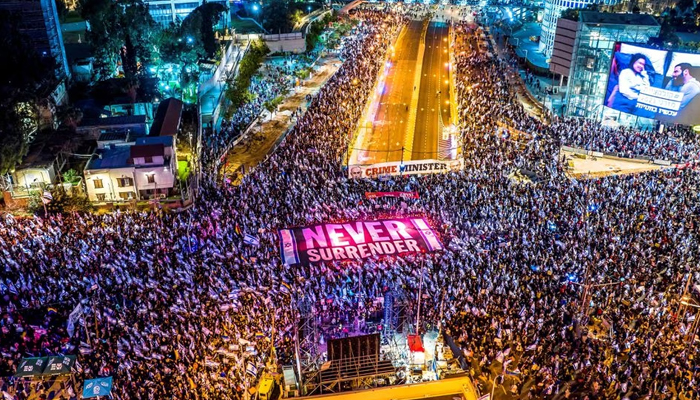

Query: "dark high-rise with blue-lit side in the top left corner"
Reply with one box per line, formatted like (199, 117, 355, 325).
(0, 0, 70, 80)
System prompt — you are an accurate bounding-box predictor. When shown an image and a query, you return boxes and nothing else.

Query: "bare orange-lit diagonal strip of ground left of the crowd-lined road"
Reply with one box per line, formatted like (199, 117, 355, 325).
(223, 57, 340, 181)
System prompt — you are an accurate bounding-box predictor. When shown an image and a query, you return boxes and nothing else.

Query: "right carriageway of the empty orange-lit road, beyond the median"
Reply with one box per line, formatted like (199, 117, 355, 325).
(411, 22, 450, 160)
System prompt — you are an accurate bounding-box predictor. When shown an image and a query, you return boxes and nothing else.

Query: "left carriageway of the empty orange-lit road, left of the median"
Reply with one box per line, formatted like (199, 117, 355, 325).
(358, 21, 423, 164)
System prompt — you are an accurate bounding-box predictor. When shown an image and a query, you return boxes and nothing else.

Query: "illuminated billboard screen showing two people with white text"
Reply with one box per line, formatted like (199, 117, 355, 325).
(605, 43, 700, 125)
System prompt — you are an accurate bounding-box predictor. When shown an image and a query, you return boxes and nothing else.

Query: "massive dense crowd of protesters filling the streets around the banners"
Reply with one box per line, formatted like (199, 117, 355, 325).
(0, 3, 700, 400)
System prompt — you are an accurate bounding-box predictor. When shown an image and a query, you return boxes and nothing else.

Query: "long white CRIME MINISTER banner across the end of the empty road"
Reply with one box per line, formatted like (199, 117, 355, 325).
(348, 159, 464, 179)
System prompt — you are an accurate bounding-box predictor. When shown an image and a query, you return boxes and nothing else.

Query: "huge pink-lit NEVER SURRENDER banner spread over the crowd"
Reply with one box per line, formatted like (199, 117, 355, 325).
(279, 218, 443, 265)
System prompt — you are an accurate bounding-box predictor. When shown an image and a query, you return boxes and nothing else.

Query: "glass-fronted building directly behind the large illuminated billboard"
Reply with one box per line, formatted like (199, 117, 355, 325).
(564, 11, 661, 125)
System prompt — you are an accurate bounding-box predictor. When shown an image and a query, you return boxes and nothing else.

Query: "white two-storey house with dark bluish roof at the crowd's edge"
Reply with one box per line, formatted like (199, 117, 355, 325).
(84, 136, 177, 203)
